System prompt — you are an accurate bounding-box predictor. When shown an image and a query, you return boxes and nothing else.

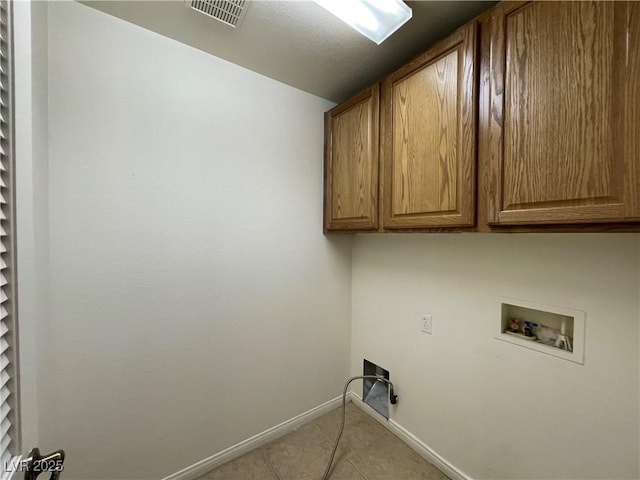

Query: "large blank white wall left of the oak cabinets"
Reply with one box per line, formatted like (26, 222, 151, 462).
(41, 2, 350, 480)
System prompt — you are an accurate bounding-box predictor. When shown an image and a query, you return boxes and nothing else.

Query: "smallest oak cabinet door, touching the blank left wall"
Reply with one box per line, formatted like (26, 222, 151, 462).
(324, 84, 380, 231)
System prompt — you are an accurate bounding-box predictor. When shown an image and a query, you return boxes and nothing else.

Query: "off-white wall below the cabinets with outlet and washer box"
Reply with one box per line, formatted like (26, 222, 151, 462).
(352, 234, 640, 479)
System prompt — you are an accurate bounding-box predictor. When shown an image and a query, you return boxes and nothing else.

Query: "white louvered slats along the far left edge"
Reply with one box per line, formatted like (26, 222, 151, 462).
(0, 0, 20, 473)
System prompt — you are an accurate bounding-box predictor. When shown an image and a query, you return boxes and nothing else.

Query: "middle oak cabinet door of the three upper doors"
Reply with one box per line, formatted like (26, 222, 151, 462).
(381, 22, 477, 228)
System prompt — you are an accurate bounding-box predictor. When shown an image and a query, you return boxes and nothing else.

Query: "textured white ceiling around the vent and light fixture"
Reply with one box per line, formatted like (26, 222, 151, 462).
(82, 0, 495, 102)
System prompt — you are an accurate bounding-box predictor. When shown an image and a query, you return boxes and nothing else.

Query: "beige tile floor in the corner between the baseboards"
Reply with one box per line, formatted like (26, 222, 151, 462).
(199, 403, 448, 480)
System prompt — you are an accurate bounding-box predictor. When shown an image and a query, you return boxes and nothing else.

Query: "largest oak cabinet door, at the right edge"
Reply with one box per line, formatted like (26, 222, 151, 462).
(488, 2, 640, 225)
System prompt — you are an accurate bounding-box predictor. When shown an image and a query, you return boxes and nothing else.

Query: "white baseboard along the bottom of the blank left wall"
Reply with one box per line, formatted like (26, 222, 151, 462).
(162, 395, 342, 480)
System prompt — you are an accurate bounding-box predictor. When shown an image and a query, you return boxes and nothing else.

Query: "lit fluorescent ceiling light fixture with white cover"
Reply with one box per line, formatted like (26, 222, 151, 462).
(315, 0, 413, 45)
